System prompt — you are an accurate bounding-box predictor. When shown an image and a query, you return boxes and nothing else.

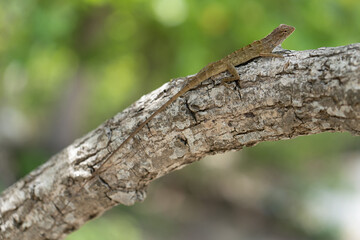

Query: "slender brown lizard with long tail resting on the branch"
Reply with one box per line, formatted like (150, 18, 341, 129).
(61, 24, 295, 216)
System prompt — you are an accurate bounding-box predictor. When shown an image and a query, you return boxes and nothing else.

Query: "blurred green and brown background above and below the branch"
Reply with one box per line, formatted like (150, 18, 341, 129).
(0, 0, 360, 240)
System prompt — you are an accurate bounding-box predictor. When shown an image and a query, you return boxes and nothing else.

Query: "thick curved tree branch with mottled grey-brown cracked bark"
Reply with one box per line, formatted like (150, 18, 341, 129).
(0, 44, 360, 240)
